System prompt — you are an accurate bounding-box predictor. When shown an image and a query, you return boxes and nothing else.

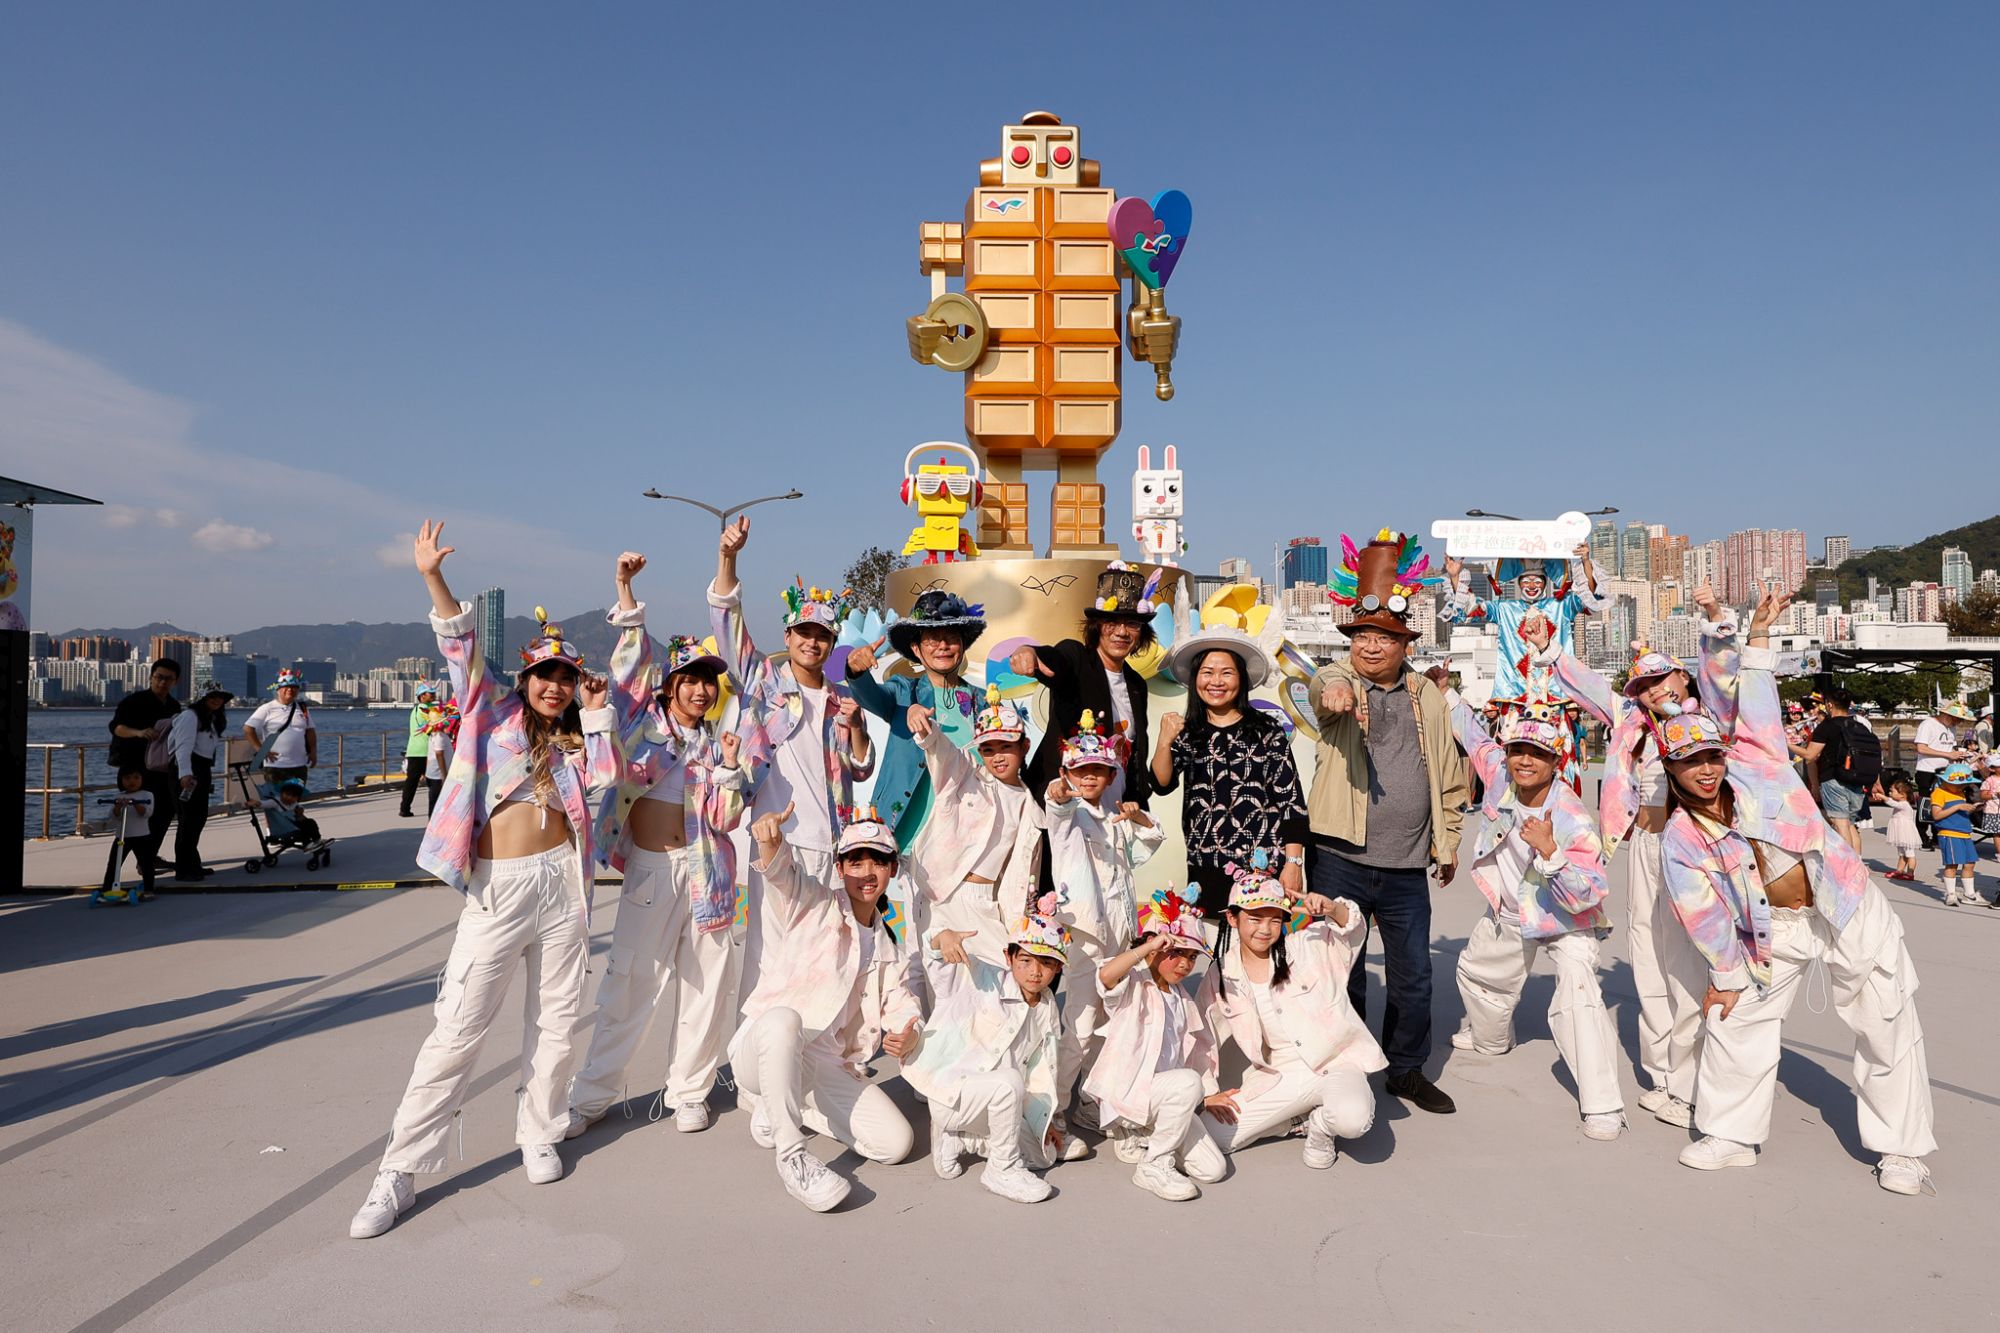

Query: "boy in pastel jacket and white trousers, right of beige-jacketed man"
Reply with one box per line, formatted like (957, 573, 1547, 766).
(1448, 691, 1624, 1143)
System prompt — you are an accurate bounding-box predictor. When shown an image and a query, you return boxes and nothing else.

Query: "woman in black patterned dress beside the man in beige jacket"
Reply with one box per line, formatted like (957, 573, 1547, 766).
(1152, 648, 1308, 921)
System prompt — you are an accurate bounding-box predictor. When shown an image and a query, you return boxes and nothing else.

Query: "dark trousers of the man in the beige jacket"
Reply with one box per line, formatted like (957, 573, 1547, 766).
(1306, 847, 1430, 1077)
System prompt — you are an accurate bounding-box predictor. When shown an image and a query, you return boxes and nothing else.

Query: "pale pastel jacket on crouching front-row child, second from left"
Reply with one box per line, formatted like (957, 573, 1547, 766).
(902, 949, 1062, 1167)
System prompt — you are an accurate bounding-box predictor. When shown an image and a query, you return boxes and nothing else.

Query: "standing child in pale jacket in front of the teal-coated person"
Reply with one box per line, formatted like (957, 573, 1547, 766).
(908, 687, 1040, 967)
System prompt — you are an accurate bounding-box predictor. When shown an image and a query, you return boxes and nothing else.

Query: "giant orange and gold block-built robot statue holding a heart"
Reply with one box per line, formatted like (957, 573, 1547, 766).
(908, 112, 1180, 558)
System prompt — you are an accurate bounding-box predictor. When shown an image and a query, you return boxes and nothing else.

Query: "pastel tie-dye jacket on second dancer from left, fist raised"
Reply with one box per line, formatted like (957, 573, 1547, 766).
(598, 602, 754, 933)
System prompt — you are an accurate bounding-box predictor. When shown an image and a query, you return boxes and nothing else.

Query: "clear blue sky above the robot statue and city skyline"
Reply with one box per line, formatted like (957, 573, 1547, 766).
(0, 4, 2000, 630)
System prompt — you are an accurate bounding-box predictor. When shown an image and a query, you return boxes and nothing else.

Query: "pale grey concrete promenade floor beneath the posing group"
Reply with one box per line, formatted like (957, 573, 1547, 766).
(0, 821, 2000, 1333)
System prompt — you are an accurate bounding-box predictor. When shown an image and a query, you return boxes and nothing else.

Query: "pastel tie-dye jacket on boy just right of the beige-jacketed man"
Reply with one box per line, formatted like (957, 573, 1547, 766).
(1450, 691, 1612, 939)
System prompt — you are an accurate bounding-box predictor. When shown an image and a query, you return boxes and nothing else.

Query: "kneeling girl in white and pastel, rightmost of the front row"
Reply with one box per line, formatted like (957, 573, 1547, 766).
(1198, 849, 1388, 1171)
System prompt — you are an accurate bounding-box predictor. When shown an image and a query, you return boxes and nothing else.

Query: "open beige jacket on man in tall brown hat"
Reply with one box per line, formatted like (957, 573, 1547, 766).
(1306, 658, 1472, 865)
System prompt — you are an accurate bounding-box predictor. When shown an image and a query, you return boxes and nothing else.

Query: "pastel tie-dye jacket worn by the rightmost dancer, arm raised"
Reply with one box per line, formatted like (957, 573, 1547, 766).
(1660, 634, 1870, 991)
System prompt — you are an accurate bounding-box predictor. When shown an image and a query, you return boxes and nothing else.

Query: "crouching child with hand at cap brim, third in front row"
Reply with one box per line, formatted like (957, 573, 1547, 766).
(1084, 885, 1228, 1203)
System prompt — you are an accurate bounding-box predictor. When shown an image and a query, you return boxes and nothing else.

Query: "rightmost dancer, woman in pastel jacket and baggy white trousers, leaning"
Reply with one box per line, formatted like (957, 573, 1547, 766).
(1660, 594, 1938, 1195)
